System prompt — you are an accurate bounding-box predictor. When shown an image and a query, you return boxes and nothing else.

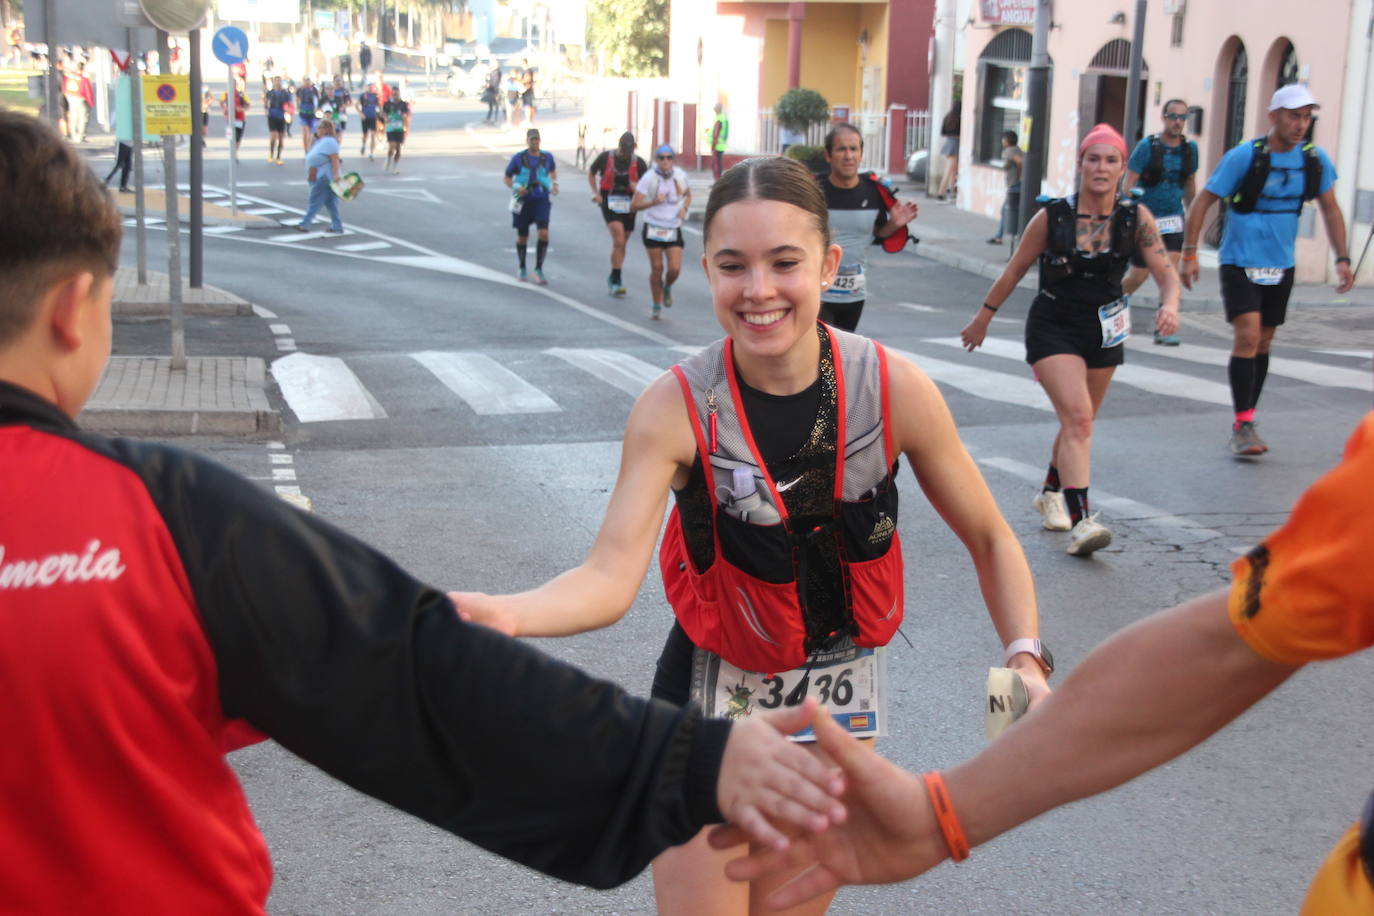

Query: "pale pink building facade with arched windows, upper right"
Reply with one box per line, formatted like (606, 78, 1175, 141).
(956, 0, 1374, 283)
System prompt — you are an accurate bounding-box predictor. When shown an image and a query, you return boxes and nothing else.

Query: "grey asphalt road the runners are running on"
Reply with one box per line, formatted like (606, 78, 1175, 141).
(115, 94, 1374, 915)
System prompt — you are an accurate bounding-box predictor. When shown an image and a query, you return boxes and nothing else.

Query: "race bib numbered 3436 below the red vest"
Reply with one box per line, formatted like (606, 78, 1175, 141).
(691, 640, 888, 742)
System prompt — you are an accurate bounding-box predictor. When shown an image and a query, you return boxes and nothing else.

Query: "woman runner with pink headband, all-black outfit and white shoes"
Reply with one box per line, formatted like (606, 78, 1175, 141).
(960, 124, 1179, 556)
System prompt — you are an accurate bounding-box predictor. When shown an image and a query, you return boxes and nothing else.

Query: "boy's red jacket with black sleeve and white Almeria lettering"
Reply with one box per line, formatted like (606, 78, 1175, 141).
(0, 383, 728, 913)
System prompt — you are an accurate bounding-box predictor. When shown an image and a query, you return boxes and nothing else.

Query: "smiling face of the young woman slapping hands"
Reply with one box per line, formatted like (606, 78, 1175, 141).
(702, 198, 841, 370)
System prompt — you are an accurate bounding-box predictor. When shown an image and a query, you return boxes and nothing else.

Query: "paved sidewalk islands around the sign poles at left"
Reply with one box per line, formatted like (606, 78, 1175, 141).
(77, 268, 282, 435)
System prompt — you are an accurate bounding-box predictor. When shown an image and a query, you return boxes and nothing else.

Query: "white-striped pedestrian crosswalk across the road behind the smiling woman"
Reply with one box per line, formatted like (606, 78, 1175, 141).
(272, 336, 1374, 433)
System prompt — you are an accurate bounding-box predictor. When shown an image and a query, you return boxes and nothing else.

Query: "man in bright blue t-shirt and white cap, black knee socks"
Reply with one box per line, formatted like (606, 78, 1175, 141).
(1183, 84, 1355, 457)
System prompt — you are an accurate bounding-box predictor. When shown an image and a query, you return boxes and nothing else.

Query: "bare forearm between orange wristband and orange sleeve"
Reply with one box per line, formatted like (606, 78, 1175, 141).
(947, 592, 1296, 845)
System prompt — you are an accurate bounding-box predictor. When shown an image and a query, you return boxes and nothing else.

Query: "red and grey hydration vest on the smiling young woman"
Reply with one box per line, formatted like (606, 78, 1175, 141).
(658, 327, 904, 672)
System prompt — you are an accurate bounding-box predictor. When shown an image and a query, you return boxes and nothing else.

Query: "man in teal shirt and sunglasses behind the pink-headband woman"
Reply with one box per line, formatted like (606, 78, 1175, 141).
(1121, 99, 1198, 346)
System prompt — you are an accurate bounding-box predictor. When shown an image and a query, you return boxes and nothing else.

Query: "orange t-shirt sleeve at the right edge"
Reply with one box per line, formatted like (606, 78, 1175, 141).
(1227, 413, 1374, 665)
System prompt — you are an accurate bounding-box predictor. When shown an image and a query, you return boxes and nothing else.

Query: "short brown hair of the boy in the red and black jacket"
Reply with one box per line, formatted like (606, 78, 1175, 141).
(0, 108, 124, 347)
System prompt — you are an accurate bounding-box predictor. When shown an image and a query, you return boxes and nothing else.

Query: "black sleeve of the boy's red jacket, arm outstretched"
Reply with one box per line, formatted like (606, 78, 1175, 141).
(110, 441, 728, 887)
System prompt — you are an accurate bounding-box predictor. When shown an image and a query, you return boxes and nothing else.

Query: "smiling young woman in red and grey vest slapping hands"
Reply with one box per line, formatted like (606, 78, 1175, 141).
(453, 158, 1051, 915)
